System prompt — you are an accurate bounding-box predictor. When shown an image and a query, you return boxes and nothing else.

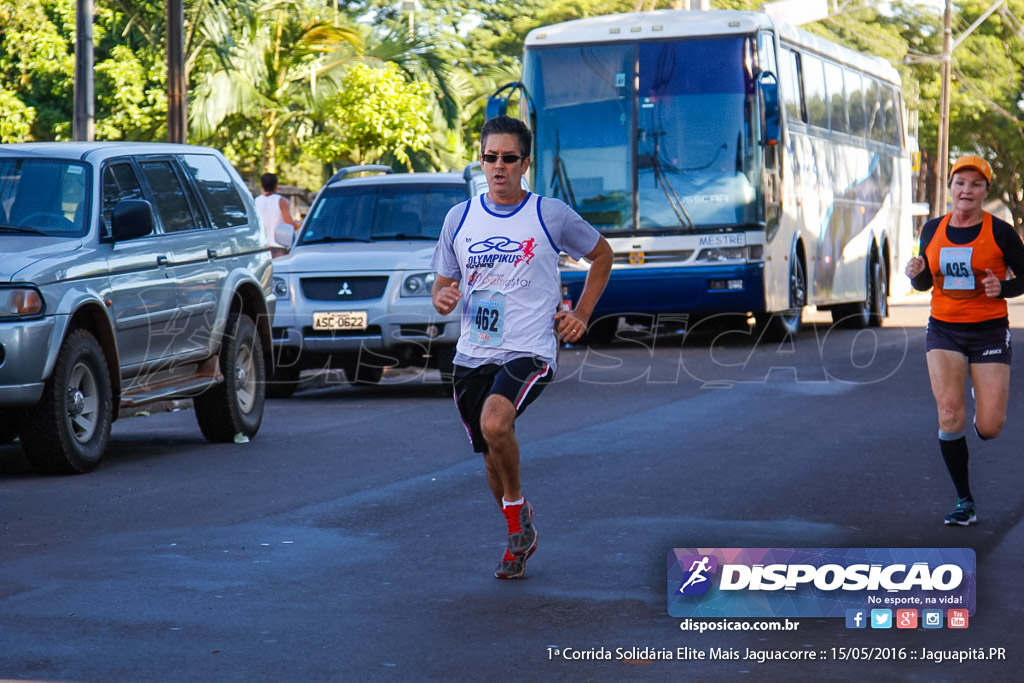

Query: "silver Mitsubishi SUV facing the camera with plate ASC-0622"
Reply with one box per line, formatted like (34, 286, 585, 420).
(267, 166, 473, 397)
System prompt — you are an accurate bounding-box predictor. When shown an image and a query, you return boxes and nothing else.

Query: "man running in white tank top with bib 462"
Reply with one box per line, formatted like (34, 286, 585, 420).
(432, 117, 612, 579)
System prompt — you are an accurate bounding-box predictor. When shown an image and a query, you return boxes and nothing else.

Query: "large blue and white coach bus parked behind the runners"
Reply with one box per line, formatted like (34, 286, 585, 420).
(488, 10, 912, 338)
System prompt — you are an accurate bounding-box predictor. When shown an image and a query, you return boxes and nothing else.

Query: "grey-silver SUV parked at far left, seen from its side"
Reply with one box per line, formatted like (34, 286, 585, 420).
(0, 142, 273, 472)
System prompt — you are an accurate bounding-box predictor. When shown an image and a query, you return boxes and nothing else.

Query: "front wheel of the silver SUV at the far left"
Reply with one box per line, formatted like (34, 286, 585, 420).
(18, 330, 114, 474)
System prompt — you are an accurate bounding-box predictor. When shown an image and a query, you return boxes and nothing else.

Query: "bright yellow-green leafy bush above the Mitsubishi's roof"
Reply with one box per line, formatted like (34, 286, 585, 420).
(303, 62, 431, 165)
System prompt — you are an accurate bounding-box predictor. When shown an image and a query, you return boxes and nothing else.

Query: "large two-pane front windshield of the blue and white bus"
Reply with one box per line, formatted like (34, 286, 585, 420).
(524, 36, 762, 236)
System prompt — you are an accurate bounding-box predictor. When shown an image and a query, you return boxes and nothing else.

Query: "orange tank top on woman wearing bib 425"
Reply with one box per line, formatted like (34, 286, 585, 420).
(925, 212, 1008, 323)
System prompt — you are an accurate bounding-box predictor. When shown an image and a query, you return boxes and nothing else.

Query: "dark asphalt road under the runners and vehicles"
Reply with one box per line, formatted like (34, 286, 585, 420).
(0, 298, 1024, 681)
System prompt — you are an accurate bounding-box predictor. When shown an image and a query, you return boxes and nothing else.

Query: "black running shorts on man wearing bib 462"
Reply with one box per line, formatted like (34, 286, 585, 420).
(453, 356, 554, 453)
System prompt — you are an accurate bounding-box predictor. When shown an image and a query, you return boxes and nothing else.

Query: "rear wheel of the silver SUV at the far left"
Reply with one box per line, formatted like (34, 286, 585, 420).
(193, 312, 266, 441)
